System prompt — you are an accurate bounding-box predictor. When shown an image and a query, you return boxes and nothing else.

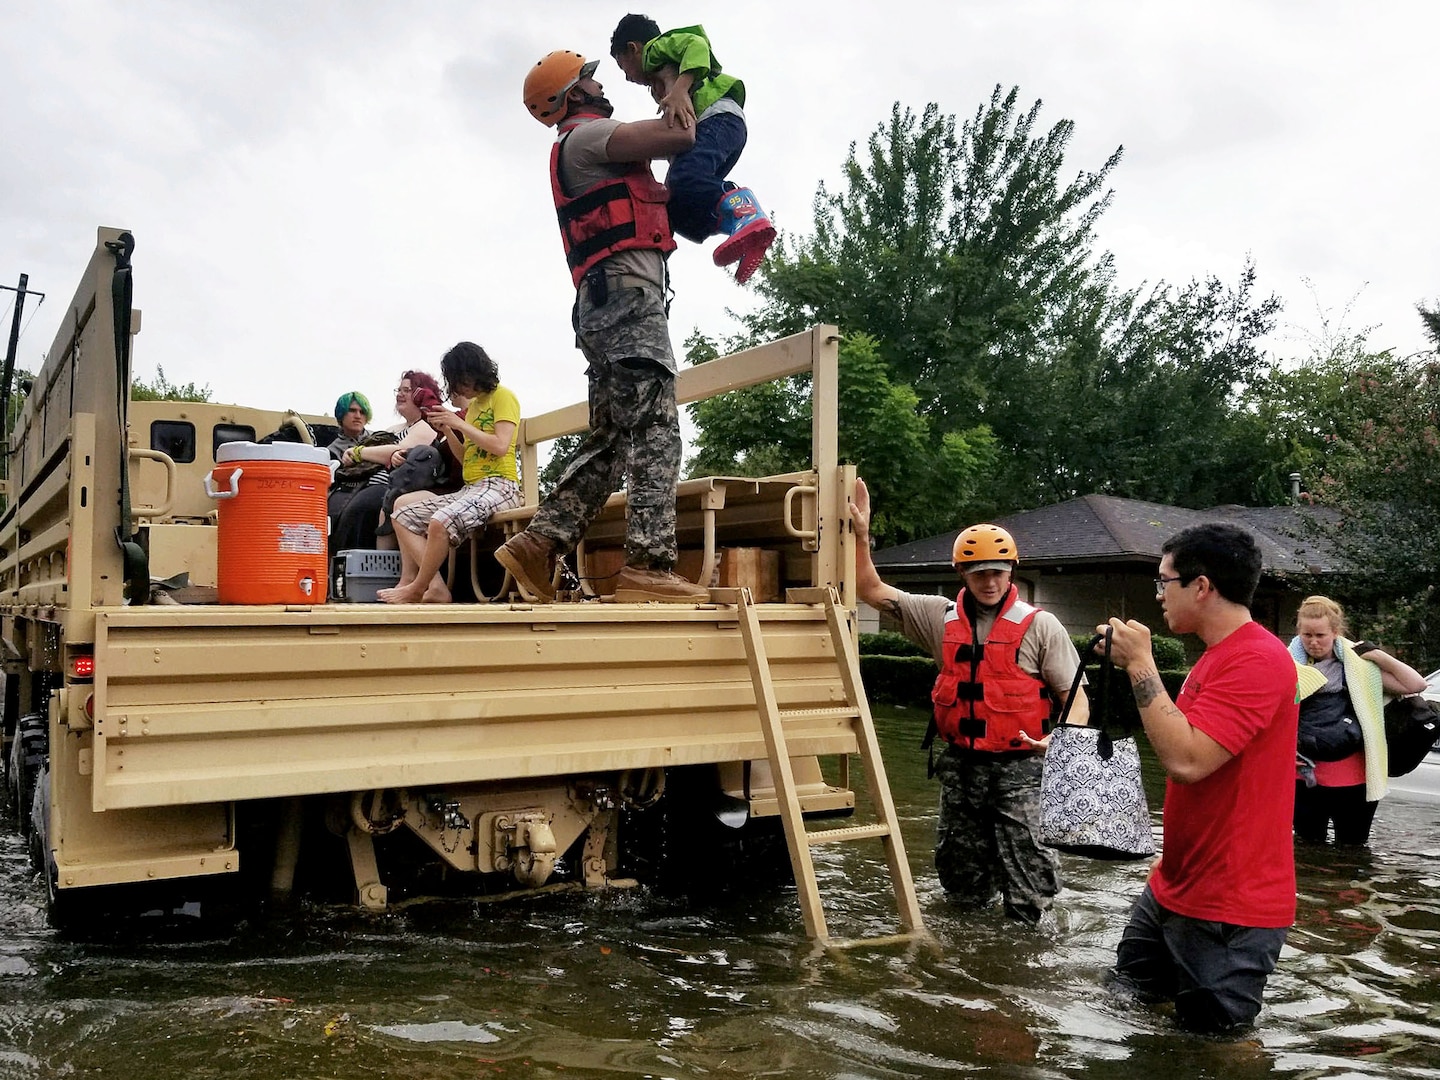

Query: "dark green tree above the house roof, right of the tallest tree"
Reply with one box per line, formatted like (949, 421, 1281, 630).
(991, 264, 1283, 508)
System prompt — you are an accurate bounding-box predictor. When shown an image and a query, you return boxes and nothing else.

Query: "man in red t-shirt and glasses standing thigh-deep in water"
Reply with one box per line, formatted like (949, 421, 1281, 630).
(1099, 524, 1299, 1032)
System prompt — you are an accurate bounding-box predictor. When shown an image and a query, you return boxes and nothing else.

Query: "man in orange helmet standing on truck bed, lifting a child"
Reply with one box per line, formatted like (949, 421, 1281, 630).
(495, 50, 710, 603)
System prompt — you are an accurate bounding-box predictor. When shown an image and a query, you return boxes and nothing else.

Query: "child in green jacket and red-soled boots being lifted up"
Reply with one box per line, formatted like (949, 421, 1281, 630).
(611, 14, 775, 284)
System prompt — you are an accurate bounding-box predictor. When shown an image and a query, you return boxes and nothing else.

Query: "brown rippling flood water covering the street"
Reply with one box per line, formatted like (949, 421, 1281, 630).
(0, 711, 1440, 1080)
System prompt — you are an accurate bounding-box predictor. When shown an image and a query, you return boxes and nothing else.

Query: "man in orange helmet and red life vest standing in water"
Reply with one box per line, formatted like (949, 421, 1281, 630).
(850, 481, 1089, 926)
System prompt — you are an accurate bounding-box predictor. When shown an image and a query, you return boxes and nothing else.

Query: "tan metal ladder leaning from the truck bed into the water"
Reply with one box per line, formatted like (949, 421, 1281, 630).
(725, 588, 924, 948)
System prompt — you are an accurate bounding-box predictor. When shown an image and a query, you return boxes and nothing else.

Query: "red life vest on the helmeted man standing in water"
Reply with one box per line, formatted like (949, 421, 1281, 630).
(930, 585, 1051, 753)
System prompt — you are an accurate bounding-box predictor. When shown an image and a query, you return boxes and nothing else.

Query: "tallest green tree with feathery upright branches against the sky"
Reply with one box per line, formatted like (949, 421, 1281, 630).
(746, 86, 1123, 435)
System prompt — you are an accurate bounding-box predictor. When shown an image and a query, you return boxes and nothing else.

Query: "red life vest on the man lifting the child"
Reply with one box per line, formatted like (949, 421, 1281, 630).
(550, 117, 675, 288)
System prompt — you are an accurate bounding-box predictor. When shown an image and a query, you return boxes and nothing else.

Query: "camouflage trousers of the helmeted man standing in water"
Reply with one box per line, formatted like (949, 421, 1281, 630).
(935, 747, 1060, 923)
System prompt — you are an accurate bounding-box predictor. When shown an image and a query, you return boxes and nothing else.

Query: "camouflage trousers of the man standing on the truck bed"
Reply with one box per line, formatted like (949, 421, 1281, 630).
(530, 288, 681, 569)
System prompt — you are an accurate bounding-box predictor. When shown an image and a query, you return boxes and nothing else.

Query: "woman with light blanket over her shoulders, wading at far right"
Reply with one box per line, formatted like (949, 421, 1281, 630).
(1290, 596, 1426, 844)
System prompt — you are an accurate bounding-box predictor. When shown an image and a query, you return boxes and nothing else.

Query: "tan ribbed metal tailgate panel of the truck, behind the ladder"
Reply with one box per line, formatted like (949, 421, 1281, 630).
(92, 603, 854, 811)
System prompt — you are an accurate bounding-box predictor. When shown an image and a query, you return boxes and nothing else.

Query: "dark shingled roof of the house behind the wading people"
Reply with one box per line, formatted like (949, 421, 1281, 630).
(874, 495, 1341, 573)
